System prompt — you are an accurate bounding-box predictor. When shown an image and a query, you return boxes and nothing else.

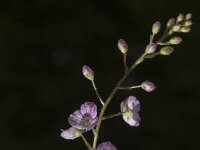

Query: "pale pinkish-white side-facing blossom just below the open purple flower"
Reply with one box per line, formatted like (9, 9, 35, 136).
(60, 127, 82, 140)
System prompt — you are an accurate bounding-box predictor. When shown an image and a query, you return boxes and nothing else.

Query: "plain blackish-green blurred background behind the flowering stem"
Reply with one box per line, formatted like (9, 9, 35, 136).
(0, 0, 200, 150)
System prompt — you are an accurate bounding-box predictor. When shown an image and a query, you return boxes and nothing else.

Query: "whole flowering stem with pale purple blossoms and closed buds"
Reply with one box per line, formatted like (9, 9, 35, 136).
(61, 13, 192, 150)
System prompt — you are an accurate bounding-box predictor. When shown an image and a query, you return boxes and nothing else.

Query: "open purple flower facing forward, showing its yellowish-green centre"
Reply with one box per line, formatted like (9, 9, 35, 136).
(68, 102, 98, 131)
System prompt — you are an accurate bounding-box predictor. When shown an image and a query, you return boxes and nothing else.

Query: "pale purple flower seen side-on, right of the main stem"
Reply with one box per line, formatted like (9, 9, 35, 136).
(121, 96, 141, 127)
